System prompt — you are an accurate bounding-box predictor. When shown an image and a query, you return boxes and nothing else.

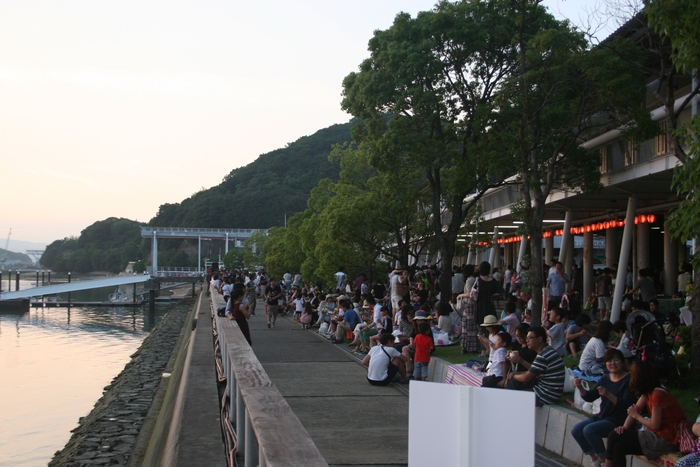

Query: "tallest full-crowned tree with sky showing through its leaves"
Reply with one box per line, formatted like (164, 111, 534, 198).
(342, 1, 530, 298)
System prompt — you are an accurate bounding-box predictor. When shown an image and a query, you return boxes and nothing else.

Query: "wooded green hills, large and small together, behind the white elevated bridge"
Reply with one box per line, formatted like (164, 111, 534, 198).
(38, 122, 354, 273)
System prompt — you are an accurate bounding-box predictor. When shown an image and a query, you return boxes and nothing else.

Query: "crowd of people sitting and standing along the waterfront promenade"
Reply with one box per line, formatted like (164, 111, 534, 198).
(210, 261, 700, 467)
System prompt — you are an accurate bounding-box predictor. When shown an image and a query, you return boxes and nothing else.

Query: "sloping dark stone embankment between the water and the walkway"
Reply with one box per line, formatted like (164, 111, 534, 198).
(49, 298, 195, 467)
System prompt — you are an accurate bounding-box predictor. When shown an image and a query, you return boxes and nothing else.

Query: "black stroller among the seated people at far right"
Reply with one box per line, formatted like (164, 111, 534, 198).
(626, 310, 684, 388)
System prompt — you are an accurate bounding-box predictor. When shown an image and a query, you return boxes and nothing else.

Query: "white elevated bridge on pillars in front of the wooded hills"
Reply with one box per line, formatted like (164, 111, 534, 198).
(141, 227, 267, 276)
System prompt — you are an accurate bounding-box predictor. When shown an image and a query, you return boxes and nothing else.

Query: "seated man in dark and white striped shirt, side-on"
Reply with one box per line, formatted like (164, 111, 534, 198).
(506, 326, 565, 407)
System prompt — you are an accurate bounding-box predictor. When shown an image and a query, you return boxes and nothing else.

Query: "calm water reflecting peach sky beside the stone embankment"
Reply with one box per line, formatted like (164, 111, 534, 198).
(0, 287, 168, 467)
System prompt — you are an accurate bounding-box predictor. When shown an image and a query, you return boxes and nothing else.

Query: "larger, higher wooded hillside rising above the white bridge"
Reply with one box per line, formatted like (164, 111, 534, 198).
(149, 121, 356, 229)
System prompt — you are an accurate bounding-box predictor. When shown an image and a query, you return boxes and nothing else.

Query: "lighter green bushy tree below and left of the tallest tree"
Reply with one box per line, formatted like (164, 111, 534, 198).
(302, 145, 431, 285)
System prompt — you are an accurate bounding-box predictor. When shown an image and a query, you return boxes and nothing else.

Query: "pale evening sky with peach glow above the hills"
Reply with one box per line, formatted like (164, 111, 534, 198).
(0, 0, 614, 251)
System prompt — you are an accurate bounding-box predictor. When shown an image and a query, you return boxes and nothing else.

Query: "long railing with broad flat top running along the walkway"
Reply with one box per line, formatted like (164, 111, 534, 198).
(211, 292, 328, 467)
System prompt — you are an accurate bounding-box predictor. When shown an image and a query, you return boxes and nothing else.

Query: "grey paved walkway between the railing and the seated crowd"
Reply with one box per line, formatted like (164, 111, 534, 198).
(249, 303, 408, 466)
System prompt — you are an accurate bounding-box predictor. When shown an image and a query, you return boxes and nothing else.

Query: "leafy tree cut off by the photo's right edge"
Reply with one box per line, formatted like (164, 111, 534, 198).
(647, 0, 700, 377)
